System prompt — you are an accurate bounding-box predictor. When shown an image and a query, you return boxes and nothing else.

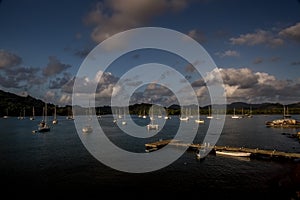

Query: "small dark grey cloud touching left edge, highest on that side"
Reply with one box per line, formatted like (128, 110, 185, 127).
(0, 49, 22, 69)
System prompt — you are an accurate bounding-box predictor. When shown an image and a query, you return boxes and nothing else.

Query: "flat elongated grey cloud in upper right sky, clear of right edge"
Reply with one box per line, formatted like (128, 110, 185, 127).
(230, 30, 284, 47)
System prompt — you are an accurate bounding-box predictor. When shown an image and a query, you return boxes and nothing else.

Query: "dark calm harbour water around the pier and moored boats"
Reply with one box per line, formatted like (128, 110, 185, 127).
(0, 116, 300, 199)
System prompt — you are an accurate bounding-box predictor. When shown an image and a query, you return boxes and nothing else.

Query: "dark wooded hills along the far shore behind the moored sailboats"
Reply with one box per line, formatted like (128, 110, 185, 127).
(0, 90, 300, 117)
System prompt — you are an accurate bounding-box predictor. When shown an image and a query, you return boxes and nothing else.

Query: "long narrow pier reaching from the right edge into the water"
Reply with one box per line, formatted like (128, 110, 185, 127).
(145, 140, 300, 160)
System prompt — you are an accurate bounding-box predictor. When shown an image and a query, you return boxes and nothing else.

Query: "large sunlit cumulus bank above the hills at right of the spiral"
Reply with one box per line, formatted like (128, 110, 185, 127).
(196, 68, 300, 103)
